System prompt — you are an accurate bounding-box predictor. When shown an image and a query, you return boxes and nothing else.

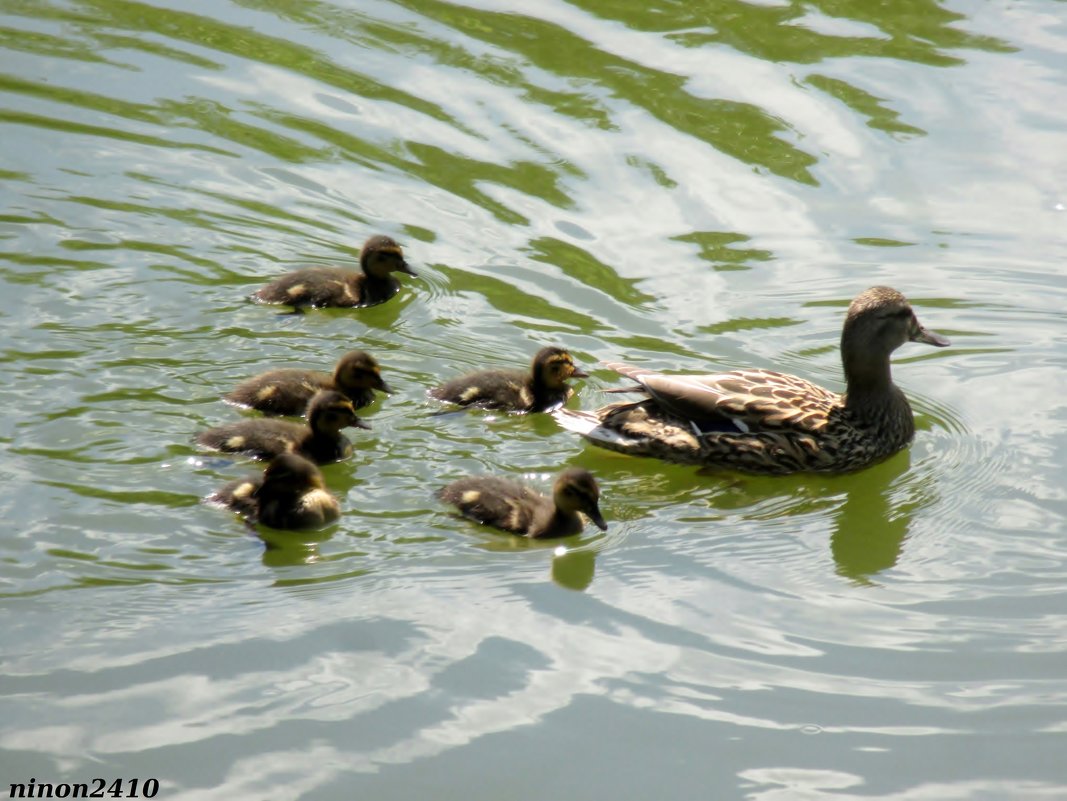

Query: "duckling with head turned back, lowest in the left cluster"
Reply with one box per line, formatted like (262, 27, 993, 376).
(205, 453, 340, 528)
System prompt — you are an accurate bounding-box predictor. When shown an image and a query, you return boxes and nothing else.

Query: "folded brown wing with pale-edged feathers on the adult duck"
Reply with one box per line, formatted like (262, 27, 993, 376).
(606, 362, 841, 433)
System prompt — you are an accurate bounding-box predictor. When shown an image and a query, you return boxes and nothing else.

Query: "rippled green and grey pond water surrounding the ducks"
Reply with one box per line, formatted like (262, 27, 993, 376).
(0, 0, 1067, 801)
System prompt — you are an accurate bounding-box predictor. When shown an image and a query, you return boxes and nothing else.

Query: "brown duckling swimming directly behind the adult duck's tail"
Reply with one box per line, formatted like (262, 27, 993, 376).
(429, 348, 589, 413)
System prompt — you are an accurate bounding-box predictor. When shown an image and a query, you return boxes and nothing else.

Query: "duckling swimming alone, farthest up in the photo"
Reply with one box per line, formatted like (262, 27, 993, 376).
(252, 235, 416, 311)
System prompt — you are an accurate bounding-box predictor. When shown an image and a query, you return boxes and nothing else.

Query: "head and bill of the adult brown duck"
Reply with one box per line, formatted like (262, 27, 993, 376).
(841, 287, 950, 364)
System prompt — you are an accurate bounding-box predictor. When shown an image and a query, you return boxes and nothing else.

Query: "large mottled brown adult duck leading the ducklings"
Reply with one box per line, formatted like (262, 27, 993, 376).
(556, 287, 949, 475)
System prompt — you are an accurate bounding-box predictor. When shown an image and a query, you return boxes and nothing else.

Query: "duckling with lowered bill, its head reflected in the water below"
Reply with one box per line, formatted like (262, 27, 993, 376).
(437, 467, 607, 540)
